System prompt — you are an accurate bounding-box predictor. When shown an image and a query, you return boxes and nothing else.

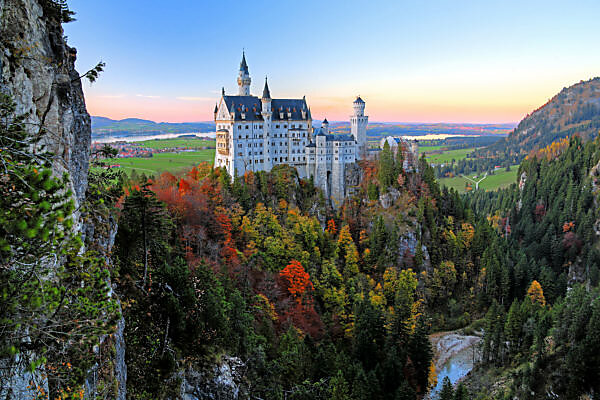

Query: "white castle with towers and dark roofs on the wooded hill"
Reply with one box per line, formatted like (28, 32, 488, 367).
(214, 55, 369, 203)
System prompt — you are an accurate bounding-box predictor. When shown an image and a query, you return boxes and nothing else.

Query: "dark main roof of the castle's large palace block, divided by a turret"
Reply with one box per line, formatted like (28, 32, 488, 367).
(223, 96, 310, 121)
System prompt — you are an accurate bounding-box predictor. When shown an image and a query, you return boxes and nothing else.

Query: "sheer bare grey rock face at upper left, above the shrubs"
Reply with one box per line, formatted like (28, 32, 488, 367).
(0, 0, 91, 202)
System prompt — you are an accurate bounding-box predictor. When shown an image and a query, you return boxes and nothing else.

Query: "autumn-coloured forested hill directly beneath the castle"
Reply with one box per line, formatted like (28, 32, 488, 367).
(109, 143, 496, 399)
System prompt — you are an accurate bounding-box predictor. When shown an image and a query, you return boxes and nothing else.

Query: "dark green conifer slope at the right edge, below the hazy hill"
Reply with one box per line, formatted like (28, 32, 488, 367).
(469, 137, 600, 399)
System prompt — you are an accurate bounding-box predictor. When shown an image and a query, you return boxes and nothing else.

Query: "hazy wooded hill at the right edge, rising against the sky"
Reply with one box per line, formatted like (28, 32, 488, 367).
(480, 78, 600, 156)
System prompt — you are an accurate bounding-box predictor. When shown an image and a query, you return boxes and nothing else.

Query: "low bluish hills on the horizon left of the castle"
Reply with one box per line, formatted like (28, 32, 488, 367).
(92, 116, 215, 138)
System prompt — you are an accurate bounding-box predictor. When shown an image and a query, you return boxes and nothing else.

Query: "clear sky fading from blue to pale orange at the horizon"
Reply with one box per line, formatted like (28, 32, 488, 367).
(64, 0, 600, 123)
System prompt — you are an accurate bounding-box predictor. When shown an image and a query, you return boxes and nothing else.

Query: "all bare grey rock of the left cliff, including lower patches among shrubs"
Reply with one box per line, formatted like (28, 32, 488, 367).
(0, 0, 126, 400)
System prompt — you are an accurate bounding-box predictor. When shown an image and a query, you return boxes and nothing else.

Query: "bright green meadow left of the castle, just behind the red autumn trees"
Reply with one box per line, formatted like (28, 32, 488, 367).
(107, 146, 215, 175)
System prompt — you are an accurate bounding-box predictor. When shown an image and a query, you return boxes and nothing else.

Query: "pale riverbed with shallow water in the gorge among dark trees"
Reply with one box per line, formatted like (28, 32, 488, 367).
(425, 332, 481, 400)
